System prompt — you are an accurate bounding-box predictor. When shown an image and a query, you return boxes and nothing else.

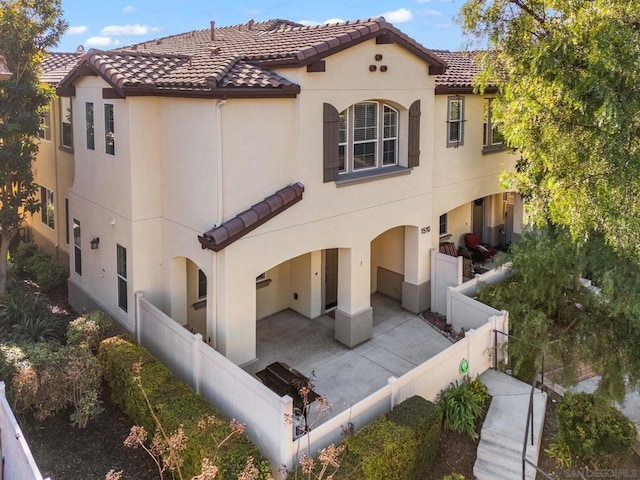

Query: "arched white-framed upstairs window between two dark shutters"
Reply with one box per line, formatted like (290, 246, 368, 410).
(338, 101, 399, 173)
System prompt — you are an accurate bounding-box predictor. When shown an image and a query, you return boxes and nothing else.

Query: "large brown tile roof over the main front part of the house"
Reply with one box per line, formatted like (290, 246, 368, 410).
(63, 18, 446, 96)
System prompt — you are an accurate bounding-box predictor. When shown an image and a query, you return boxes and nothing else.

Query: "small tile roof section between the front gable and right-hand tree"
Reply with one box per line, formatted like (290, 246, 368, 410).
(434, 50, 497, 93)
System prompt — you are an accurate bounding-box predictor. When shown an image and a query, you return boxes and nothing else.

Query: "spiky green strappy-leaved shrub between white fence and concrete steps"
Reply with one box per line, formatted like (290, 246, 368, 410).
(437, 378, 489, 440)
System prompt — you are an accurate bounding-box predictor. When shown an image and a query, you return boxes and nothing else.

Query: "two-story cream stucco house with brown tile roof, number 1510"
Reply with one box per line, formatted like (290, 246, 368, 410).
(31, 18, 522, 365)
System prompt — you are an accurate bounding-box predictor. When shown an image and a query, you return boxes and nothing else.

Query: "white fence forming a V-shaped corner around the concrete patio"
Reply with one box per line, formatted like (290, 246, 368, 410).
(136, 293, 509, 478)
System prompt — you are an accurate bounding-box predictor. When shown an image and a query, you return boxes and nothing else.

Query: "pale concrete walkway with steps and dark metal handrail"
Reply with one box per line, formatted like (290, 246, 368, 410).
(473, 370, 547, 480)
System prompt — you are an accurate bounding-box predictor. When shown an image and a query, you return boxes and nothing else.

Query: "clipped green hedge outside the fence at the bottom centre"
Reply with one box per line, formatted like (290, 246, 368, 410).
(289, 396, 442, 480)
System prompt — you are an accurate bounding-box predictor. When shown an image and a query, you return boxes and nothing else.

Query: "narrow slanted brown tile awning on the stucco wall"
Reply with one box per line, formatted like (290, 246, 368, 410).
(198, 182, 304, 252)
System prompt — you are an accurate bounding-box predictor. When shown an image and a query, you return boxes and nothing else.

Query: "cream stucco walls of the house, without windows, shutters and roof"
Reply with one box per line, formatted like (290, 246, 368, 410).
(62, 40, 520, 364)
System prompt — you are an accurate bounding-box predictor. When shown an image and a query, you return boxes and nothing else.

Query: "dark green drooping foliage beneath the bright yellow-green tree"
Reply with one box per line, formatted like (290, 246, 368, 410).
(479, 226, 640, 400)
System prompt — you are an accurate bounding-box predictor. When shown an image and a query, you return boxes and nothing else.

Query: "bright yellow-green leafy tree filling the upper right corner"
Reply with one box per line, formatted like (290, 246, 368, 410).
(460, 0, 640, 261)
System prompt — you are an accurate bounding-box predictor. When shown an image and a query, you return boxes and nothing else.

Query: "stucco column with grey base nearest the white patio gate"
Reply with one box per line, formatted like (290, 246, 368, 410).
(402, 227, 431, 313)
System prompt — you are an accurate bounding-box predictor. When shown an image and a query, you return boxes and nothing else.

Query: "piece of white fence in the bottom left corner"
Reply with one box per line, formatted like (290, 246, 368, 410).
(0, 382, 49, 480)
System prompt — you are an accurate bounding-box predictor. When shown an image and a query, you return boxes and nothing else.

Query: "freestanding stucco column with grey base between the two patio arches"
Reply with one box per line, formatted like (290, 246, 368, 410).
(335, 243, 373, 347)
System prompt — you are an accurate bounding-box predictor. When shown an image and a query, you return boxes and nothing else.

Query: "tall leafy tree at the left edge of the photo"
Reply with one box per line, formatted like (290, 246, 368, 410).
(0, 0, 67, 295)
